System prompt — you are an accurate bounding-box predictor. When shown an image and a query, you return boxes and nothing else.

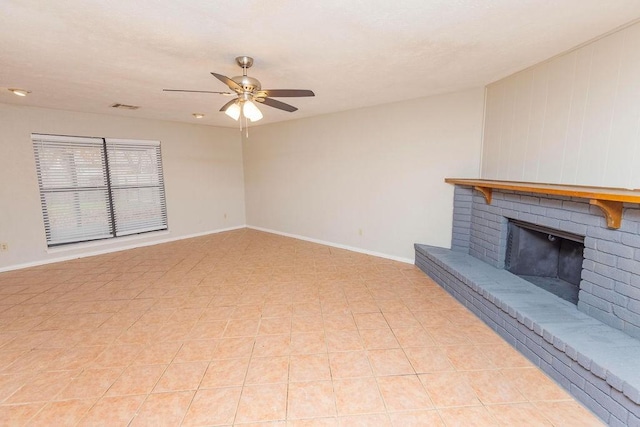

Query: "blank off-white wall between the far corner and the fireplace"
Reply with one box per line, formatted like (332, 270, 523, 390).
(243, 89, 484, 262)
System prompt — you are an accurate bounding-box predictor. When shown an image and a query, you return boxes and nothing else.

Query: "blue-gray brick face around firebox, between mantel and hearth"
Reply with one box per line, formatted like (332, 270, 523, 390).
(452, 186, 640, 338)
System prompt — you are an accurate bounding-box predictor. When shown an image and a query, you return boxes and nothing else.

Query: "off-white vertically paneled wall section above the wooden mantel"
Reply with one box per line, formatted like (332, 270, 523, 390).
(482, 23, 640, 188)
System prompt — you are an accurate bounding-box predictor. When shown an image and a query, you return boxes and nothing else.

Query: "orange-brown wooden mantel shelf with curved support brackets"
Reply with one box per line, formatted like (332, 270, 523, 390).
(445, 178, 640, 228)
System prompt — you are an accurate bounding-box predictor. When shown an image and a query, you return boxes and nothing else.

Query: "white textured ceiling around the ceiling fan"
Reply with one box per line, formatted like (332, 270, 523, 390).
(0, 0, 640, 127)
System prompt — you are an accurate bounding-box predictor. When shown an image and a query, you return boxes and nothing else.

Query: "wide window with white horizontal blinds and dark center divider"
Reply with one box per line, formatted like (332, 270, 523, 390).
(31, 134, 167, 246)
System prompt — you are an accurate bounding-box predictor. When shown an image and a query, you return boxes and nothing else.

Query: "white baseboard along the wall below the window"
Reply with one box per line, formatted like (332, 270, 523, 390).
(0, 225, 247, 273)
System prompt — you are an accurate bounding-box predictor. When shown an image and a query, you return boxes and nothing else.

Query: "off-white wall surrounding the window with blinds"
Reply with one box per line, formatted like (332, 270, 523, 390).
(0, 104, 245, 271)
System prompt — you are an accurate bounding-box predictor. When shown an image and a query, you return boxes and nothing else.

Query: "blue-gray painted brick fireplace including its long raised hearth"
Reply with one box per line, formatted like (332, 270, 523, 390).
(416, 180, 640, 425)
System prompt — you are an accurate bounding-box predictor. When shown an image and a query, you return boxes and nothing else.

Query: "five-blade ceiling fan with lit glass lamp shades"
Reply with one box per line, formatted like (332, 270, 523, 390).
(162, 56, 315, 122)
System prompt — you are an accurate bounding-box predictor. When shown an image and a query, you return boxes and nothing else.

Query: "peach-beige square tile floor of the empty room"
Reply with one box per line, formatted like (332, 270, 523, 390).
(0, 230, 600, 427)
